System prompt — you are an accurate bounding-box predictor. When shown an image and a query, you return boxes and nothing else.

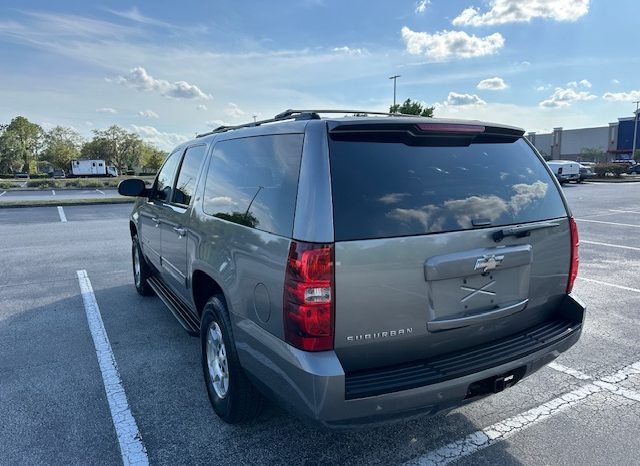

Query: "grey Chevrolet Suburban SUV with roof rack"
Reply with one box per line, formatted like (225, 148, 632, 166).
(118, 110, 585, 429)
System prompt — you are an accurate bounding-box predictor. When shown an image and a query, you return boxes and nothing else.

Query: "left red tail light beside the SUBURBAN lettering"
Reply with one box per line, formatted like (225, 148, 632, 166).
(283, 241, 334, 351)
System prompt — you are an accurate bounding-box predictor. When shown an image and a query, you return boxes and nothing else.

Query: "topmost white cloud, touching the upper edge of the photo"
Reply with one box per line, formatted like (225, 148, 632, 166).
(453, 0, 589, 26)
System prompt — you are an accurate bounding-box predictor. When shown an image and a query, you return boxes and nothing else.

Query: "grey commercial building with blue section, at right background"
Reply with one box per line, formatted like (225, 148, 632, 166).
(527, 117, 640, 161)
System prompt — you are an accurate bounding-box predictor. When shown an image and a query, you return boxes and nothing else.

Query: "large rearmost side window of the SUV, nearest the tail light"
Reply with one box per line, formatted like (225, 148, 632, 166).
(203, 134, 303, 236)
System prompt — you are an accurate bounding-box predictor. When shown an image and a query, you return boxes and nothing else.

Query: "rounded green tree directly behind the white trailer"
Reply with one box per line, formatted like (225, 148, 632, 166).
(87, 125, 142, 172)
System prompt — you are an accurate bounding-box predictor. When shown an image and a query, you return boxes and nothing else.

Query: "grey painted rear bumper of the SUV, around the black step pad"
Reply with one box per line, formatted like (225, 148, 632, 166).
(235, 296, 585, 430)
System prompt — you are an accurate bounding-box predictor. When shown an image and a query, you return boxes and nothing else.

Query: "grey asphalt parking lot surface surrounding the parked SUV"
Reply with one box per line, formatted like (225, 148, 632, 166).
(0, 183, 640, 465)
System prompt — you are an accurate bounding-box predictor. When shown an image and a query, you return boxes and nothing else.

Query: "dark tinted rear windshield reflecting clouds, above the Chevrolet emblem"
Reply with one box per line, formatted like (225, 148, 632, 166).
(329, 139, 567, 241)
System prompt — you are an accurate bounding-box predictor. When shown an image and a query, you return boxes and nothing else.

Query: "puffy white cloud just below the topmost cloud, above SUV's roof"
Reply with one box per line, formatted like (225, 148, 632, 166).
(401, 26, 504, 60)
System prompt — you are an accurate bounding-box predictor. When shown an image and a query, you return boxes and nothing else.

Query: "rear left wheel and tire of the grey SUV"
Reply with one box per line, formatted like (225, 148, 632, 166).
(200, 295, 264, 424)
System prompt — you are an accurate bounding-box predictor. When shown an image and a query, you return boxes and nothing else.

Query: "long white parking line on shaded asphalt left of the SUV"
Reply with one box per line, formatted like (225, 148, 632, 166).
(77, 270, 149, 466)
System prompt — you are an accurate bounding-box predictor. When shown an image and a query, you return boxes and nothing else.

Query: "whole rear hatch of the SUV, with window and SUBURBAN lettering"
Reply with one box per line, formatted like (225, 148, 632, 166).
(329, 120, 571, 372)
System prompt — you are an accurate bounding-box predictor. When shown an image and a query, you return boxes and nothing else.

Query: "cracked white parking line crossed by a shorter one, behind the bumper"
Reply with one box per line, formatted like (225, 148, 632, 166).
(404, 362, 640, 466)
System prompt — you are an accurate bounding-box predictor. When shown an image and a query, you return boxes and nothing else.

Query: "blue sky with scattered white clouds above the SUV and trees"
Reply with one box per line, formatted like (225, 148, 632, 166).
(0, 0, 640, 150)
